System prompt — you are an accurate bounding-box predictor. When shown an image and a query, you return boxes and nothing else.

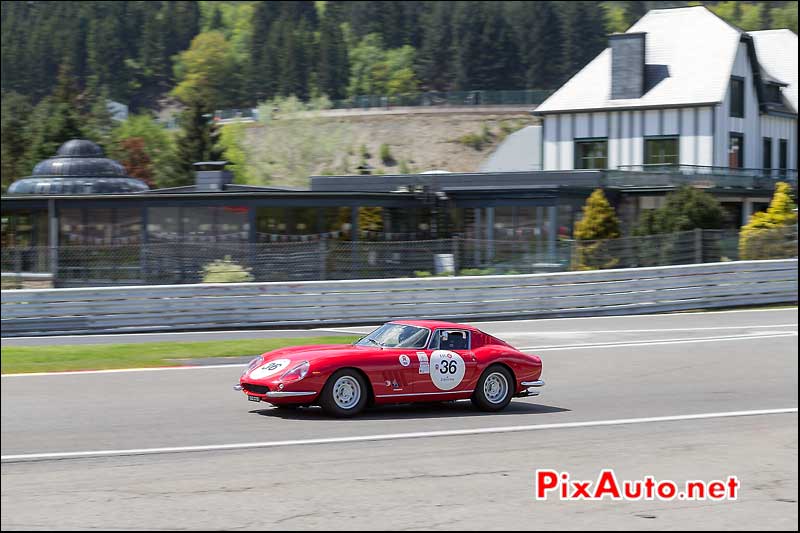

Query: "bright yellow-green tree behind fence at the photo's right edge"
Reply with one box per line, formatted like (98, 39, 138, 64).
(739, 182, 797, 259)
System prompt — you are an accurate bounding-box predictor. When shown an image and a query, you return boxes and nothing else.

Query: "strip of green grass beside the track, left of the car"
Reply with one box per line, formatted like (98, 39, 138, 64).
(0, 336, 358, 374)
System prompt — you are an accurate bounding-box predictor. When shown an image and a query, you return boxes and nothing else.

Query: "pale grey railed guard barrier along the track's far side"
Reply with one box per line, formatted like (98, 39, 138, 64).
(2, 259, 797, 337)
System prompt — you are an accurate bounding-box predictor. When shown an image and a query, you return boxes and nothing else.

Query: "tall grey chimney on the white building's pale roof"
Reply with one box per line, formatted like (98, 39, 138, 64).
(608, 32, 647, 100)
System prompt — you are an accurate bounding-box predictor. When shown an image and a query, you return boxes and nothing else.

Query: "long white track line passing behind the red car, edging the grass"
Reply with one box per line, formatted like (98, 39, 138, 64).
(0, 331, 797, 378)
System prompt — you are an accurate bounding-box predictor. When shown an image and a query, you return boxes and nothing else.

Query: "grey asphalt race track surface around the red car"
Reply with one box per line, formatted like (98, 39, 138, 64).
(2, 308, 798, 530)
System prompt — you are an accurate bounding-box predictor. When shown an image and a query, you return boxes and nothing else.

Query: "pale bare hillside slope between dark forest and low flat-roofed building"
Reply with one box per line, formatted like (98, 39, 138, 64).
(239, 110, 534, 187)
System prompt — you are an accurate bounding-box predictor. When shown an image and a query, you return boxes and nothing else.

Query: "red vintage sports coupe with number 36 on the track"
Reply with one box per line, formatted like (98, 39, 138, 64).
(234, 320, 544, 417)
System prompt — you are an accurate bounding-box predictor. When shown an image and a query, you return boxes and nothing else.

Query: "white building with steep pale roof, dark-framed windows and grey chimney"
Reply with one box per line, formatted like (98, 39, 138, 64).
(534, 7, 798, 176)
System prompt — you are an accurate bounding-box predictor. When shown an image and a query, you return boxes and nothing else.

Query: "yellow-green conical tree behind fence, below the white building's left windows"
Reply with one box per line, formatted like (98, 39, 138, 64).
(573, 189, 620, 270)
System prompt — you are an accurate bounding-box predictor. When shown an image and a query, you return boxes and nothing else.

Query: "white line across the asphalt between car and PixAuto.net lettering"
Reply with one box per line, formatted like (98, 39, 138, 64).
(0, 407, 797, 463)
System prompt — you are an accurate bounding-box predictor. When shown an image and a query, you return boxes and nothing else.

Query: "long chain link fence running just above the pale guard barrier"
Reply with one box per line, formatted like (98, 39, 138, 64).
(1, 225, 797, 288)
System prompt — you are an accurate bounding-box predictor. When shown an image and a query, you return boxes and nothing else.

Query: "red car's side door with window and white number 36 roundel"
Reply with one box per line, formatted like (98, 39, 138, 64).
(413, 328, 477, 398)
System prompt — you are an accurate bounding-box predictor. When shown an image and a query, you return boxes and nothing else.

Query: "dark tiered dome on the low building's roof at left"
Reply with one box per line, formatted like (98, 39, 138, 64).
(8, 139, 148, 195)
